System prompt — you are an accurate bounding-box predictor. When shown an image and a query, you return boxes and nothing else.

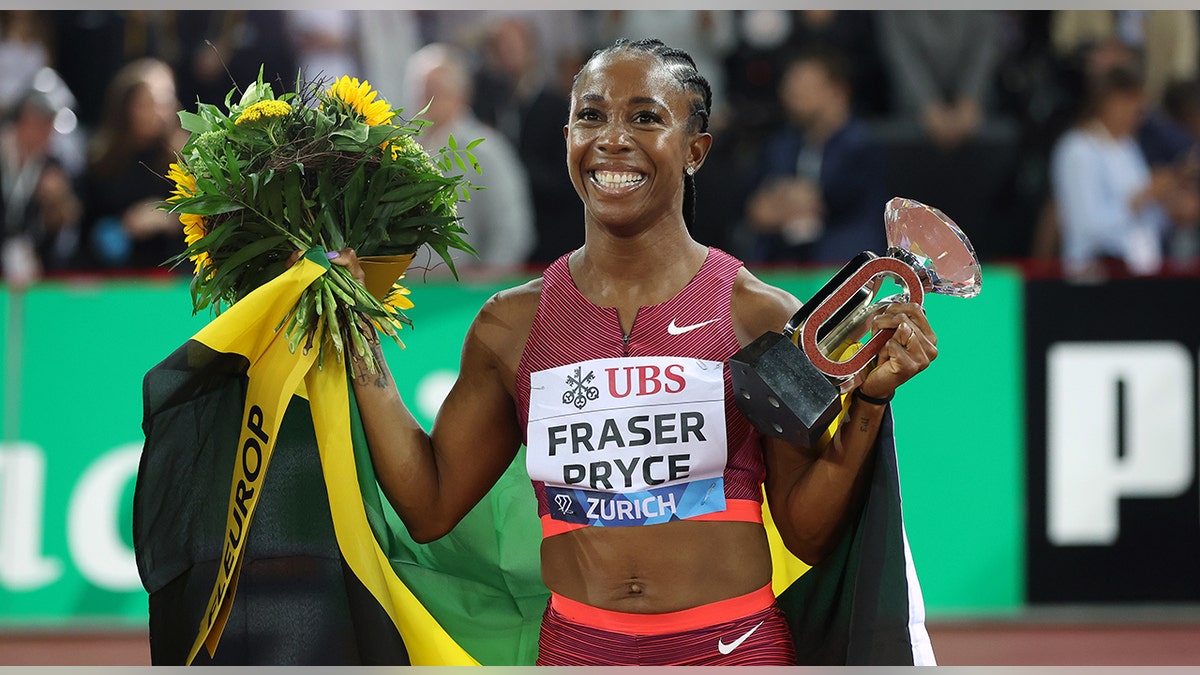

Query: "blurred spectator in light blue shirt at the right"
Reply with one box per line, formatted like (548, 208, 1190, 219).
(1050, 60, 1180, 280)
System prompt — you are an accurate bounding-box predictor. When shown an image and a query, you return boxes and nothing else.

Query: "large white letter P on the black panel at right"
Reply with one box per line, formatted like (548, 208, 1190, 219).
(1046, 342, 1195, 545)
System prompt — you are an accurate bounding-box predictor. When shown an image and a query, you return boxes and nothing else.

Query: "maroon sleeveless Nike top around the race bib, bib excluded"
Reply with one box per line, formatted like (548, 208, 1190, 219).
(516, 247, 766, 537)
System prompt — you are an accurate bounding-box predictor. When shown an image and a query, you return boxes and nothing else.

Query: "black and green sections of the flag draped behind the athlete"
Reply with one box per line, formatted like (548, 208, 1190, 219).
(133, 341, 932, 665)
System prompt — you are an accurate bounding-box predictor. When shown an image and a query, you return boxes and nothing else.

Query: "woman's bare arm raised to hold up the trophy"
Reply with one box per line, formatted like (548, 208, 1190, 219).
(734, 266, 937, 565)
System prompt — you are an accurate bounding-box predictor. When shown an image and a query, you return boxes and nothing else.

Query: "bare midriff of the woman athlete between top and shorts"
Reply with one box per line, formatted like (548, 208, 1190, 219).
(541, 520, 770, 614)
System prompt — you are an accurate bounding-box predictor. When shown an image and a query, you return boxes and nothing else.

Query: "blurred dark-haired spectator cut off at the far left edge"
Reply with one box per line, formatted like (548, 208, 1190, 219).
(0, 90, 82, 285)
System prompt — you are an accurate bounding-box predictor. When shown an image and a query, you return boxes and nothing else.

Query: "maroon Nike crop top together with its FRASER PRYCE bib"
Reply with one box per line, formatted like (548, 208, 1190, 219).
(516, 249, 766, 537)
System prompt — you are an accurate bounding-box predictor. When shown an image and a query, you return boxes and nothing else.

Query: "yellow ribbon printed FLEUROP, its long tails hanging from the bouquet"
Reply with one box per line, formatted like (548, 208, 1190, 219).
(186, 249, 479, 665)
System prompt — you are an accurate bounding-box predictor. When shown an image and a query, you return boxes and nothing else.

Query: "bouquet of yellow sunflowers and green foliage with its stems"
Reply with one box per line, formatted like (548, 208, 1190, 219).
(162, 71, 482, 370)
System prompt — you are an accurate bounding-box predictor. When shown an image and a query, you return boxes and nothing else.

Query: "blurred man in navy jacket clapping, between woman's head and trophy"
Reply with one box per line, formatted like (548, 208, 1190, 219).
(745, 48, 888, 264)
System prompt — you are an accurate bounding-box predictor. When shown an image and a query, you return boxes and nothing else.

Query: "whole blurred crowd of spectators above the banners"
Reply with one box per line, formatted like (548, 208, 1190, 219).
(0, 10, 1200, 283)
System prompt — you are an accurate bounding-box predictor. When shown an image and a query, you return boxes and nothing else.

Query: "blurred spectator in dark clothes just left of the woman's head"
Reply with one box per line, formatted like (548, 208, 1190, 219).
(472, 17, 583, 264)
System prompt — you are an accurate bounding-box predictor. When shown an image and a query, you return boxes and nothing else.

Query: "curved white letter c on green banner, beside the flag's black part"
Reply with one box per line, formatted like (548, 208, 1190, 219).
(67, 443, 142, 592)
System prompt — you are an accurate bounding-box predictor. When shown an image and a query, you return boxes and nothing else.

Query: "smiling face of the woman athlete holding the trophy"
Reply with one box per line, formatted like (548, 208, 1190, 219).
(564, 52, 712, 231)
